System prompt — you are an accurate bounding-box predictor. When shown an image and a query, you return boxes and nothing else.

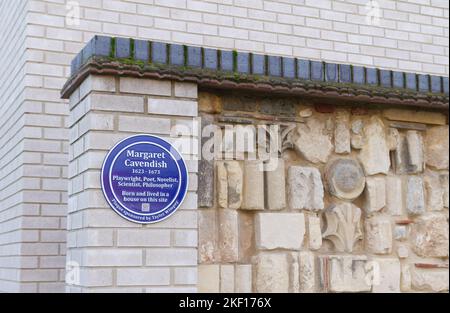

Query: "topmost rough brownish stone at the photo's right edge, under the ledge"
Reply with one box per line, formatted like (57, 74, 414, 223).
(425, 125, 449, 170)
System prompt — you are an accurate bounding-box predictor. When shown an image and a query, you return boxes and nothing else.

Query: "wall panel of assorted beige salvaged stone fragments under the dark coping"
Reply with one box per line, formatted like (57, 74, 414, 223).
(198, 92, 449, 292)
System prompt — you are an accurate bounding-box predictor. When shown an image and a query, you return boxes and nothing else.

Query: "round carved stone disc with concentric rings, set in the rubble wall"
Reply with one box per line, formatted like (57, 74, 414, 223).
(325, 159, 366, 200)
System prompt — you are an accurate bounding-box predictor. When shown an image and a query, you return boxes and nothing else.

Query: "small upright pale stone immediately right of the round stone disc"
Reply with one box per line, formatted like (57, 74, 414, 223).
(364, 177, 386, 214)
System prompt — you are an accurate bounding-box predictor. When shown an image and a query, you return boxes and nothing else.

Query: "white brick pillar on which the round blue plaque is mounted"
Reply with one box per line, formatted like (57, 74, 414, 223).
(67, 76, 197, 292)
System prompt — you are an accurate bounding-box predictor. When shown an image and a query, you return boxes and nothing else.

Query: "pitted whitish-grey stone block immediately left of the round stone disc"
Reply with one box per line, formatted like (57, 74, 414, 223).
(288, 166, 324, 211)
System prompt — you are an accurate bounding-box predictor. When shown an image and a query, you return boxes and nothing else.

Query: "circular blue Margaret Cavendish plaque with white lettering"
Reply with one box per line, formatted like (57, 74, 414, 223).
(101, 135, 188, 224)
